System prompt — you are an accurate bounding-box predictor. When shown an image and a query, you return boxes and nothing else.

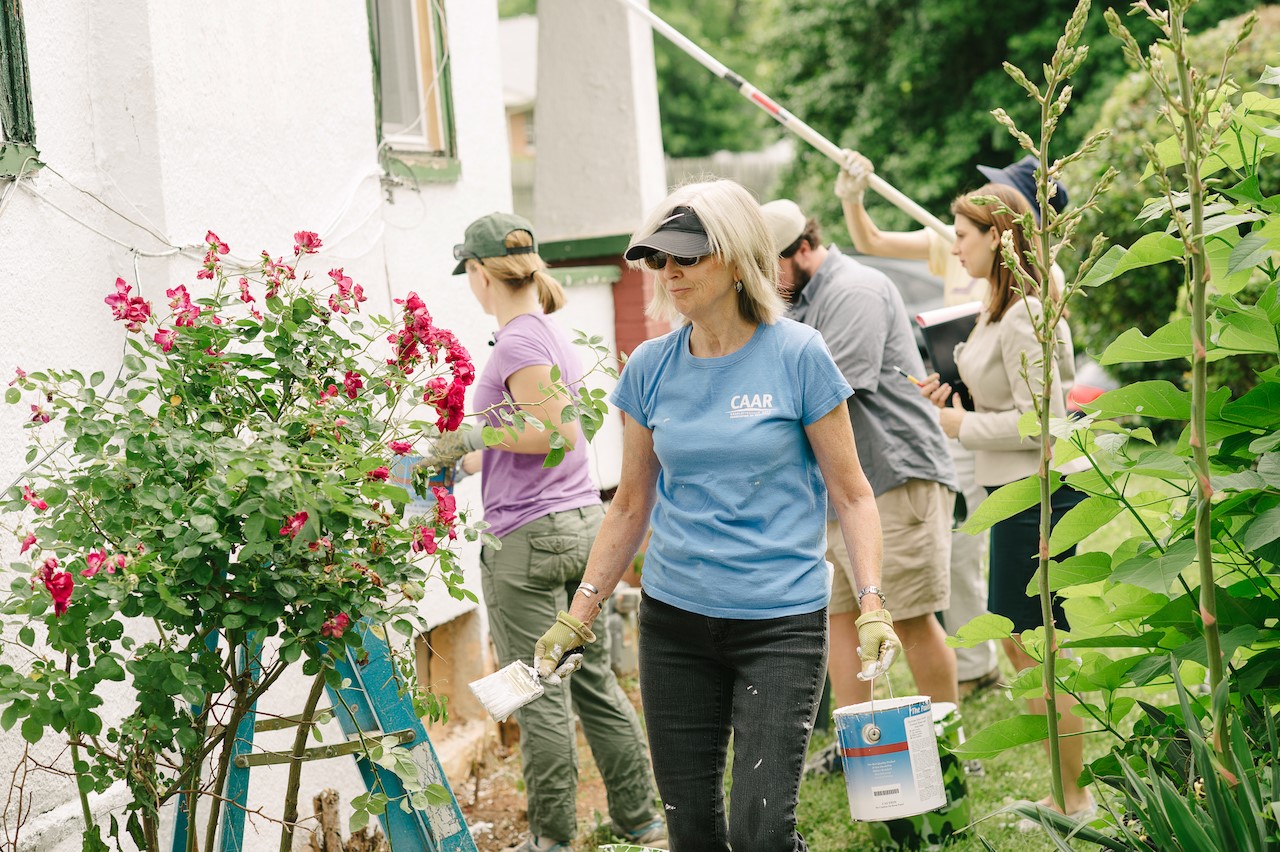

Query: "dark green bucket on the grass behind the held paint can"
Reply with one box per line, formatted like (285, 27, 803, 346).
(868, 701, 969, 849)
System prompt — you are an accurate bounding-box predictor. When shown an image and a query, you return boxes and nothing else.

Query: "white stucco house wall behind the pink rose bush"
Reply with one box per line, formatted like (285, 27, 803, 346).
(0, 0, 604, 851)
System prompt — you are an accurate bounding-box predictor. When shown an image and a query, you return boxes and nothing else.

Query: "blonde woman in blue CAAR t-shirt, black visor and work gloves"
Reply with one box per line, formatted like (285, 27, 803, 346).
(535, 180, 897, 852)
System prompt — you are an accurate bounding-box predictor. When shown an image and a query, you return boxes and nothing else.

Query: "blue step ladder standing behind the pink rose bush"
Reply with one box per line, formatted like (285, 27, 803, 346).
(173, 622, 476, 852)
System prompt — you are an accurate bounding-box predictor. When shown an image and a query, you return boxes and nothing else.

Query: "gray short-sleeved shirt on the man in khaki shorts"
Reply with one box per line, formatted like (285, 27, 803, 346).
(790, 246, 957, 496)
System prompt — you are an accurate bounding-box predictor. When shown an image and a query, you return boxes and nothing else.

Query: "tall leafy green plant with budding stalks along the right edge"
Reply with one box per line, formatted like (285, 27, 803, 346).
(961, 0, 1280, 848)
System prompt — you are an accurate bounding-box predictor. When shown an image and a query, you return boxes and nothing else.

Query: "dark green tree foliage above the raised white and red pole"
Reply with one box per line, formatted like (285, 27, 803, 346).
(764, 0, 1257, 228)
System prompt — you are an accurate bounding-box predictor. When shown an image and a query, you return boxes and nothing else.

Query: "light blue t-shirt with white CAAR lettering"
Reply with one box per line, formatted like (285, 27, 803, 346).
(611, 320, 852, 619)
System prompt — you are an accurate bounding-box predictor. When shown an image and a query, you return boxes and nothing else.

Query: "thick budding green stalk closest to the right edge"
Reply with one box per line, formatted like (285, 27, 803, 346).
(1169, 3, 1224, 716)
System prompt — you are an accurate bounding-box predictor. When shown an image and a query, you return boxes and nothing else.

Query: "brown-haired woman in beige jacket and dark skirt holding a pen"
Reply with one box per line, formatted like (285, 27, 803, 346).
(920, 184, 1096, 826)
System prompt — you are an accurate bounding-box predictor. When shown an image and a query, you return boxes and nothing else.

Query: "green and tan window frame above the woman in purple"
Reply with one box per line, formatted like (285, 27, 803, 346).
(368, 0, 462, 183)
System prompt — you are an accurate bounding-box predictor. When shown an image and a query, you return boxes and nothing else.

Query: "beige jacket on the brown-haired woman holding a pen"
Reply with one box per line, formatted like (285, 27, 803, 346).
(956, 298, 1083, 486)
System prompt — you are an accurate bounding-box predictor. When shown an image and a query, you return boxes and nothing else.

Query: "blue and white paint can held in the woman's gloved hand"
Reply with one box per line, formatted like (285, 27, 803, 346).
(835, 695, 947, 821)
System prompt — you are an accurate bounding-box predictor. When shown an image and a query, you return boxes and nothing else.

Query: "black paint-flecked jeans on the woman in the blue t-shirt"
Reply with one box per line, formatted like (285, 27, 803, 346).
(640, 595, 827, 852)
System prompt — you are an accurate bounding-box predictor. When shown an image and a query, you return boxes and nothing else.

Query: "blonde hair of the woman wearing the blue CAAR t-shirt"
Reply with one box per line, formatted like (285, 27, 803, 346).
(628, 180, 786, 325)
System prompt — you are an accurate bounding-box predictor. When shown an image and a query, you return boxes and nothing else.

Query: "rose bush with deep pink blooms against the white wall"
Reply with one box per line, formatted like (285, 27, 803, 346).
(0, 230, 494, 848)
